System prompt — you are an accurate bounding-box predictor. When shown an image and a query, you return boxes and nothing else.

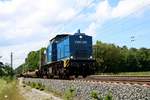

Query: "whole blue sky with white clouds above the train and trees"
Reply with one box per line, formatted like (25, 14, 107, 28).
(0, 0, 150, 68)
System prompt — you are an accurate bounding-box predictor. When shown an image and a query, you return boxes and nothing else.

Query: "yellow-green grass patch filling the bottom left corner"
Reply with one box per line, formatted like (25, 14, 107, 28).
(0, 78, 24, 100)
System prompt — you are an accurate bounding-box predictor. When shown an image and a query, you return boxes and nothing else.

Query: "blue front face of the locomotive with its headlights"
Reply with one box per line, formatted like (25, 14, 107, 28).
(70, 30, 92, 60)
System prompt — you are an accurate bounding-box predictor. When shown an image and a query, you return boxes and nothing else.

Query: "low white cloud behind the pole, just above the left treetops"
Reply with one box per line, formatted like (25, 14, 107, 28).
(0, 41, 47, 68)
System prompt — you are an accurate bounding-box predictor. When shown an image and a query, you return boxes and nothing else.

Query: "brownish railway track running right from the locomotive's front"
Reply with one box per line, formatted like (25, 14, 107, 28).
(76, 75, 150, 87)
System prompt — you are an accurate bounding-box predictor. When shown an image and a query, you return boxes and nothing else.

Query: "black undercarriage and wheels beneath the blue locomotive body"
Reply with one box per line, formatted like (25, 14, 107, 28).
(38, 60, 94, 79)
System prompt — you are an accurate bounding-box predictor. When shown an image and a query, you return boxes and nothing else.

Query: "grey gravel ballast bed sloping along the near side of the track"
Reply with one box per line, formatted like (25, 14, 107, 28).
(24, 78, 150, 100)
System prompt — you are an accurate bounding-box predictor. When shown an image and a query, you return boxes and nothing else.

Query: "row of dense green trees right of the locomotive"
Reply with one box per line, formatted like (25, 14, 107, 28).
(93, 41, 150, 73)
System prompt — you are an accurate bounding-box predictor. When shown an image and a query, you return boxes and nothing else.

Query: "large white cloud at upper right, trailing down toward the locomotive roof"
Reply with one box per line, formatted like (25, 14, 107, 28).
(86, 0, 150, 35)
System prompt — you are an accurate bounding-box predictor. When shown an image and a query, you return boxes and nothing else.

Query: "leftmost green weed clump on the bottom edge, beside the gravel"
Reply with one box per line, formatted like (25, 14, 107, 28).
(64, 87, 76, 100)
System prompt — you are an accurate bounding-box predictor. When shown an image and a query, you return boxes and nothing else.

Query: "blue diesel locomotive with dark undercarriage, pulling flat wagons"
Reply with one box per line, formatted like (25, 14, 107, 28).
(38, 30, 94, 78)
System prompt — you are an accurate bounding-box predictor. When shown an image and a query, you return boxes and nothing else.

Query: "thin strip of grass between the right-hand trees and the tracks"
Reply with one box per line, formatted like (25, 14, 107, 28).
(98, 71, 150, 76)
